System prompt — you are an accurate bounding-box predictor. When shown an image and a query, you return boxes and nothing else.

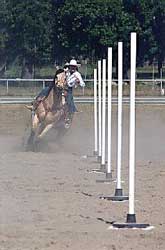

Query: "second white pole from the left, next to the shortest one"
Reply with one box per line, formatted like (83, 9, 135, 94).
(98, 61, 102, 159)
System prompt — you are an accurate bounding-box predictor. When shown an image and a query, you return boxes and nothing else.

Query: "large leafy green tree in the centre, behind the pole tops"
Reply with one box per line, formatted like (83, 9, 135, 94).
(53, 0, 140, 75)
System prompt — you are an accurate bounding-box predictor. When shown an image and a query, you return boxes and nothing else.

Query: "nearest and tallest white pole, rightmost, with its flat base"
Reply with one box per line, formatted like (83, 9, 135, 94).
(113, 32, 150, 229)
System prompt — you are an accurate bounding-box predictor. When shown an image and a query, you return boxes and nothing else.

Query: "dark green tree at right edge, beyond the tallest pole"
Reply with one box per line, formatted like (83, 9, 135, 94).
(124, 0, 165, 75)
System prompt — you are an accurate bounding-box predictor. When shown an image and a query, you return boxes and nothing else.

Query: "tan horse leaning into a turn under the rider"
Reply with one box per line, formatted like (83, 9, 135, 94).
(26, 72, 72, 150)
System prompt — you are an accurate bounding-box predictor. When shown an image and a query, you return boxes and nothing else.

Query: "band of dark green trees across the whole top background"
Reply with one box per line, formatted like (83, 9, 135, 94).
(0, 0, 165, 77)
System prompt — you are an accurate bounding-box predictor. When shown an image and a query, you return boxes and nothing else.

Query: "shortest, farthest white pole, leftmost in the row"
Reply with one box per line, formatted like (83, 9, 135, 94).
(94, 69, 98, 155)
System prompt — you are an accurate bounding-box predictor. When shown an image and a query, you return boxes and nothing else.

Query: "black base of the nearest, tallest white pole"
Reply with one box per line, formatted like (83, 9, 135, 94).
(113, 214, 150, 229)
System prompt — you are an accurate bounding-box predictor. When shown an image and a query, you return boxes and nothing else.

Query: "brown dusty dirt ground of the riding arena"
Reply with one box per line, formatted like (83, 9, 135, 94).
(0, 105, 165, 250)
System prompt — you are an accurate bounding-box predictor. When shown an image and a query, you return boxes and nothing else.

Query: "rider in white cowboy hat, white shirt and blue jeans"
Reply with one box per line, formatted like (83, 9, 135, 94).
(66, 59, 85, 114)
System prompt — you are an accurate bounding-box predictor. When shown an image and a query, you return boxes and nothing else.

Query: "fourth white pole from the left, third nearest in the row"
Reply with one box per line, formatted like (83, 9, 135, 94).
(107, 48, 112, 174)
